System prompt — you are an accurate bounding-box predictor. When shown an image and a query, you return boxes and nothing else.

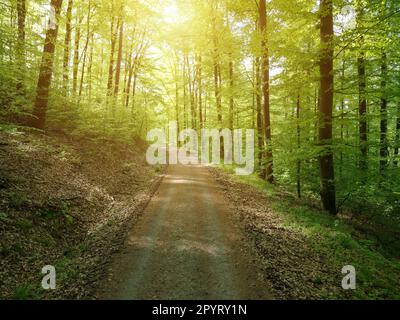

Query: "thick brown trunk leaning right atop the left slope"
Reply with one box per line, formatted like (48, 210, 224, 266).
(32, 0, 62, 130)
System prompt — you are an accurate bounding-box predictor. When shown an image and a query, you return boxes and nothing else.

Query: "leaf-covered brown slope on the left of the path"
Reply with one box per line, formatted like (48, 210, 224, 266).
(0, 126, 162, 299)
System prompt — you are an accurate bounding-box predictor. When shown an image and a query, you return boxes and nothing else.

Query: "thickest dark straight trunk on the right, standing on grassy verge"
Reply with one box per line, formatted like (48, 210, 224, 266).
(319, 0, 337, 214)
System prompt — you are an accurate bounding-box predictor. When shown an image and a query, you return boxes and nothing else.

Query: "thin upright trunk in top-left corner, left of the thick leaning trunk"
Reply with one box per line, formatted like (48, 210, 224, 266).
(17, 0, 26, 94)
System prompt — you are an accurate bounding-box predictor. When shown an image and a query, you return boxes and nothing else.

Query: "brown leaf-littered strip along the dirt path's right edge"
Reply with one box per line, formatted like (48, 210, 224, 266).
(210, 168, 348, 299)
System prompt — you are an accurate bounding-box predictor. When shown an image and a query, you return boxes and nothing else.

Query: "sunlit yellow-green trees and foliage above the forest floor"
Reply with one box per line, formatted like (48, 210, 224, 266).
(0, 0, 400, 215)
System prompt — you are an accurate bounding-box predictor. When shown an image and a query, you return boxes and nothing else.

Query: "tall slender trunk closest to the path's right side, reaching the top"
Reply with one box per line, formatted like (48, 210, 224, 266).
(259, 0, 274, 183)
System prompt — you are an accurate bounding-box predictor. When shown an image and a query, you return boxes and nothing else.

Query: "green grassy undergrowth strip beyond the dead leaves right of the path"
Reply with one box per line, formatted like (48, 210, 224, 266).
(222, 166, 400, 299)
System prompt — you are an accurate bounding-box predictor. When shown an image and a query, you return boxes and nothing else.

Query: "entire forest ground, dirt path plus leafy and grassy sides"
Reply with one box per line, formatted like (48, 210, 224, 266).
(0, 127, 400, 299)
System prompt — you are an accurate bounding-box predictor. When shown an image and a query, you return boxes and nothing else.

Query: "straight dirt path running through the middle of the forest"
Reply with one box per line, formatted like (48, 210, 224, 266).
(100, 165, 271, 300)
